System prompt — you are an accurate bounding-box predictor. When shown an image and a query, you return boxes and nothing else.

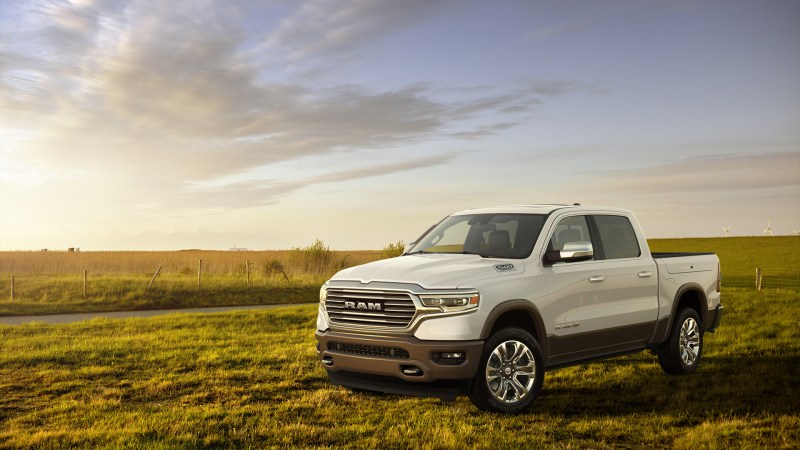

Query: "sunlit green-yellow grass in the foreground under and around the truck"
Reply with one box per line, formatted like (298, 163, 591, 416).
(0, 290, 800, 449)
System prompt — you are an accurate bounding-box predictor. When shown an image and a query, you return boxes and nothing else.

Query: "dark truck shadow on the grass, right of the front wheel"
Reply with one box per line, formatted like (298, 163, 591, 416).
(529, 356, 800, 417)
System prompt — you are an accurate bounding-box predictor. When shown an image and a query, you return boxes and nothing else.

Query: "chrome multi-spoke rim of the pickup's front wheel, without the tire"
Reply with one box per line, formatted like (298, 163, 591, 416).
(486, 341, 536, 404)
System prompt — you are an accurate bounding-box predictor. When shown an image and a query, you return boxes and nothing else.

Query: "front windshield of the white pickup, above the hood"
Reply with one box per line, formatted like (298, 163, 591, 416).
(408, 214, 546, 259)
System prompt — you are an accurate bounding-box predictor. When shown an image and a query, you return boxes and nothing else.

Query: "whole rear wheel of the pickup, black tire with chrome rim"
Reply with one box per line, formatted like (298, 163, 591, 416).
(658, 308, 703, 375)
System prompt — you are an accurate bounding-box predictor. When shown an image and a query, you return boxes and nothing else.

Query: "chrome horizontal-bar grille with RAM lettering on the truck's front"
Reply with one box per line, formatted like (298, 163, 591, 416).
(325, 287, 417, 328)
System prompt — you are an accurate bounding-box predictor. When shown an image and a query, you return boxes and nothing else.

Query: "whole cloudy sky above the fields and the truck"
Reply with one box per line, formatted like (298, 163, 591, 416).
(0, 0, 800, 250)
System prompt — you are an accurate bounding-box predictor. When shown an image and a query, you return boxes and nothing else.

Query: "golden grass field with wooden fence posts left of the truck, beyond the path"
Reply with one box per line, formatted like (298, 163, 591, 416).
(0, 243, 382, 316)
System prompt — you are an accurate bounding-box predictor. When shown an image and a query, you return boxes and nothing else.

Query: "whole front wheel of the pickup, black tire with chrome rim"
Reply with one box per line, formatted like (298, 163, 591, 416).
(469, 328, 544, 414)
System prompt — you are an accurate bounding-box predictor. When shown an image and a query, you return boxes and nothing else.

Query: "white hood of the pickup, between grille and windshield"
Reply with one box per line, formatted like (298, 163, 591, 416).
(331, 253, 525, 289)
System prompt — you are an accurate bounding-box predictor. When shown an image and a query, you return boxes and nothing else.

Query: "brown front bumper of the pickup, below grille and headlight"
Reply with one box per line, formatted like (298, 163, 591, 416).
(315, 331, 483, 384)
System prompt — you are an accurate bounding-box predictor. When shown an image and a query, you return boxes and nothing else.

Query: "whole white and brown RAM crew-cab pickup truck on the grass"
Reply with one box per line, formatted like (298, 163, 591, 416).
(316, 204, 722, 413)
